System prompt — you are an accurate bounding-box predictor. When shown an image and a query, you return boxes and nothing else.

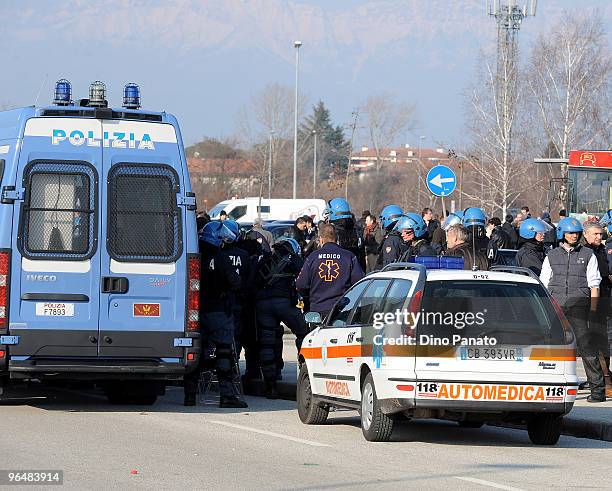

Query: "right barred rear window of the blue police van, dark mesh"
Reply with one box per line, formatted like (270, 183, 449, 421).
(108, 164, 183, 262)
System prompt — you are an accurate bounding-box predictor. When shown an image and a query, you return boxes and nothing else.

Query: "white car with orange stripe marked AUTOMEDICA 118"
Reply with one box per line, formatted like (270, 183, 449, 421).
(297, 263, 578, 445)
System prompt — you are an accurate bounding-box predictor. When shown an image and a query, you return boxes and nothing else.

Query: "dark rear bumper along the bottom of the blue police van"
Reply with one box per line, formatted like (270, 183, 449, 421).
(8, 358, 197, 380)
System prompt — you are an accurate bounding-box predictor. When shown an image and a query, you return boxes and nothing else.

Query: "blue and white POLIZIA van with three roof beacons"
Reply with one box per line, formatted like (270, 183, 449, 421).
(0, 80, 200, 404)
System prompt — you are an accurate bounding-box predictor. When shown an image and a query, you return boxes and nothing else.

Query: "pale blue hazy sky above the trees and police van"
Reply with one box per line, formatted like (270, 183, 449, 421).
(0, 0, 612, 146)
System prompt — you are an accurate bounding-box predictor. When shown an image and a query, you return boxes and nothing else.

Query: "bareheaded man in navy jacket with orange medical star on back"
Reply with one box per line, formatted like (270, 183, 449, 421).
(296, 224, 363, 319)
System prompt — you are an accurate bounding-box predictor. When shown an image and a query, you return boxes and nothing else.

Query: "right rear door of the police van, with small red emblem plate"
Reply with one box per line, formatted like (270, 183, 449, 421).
(99, 120, 187, 363)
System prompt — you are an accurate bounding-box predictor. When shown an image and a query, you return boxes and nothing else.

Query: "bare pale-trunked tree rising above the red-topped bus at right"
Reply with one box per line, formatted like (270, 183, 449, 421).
(527, 13, 612, 158)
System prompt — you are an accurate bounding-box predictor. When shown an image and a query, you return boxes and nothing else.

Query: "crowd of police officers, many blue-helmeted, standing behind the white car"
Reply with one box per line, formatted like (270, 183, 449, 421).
(184, 198, 612, 408)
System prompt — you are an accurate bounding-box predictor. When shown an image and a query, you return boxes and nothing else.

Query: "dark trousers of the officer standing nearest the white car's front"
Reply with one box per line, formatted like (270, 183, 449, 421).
(256, 297, 308, 381)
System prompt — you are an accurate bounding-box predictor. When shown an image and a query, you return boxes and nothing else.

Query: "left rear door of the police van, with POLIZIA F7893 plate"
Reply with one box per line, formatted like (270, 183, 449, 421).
(9, 118, 102, 365)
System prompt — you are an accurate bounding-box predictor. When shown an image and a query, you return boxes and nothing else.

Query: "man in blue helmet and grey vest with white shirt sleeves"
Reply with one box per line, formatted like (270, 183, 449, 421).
(540, 217, 606, 402)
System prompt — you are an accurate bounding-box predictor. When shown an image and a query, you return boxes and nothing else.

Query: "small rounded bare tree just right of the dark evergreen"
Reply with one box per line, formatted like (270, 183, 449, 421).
(361, 94, 415, 208)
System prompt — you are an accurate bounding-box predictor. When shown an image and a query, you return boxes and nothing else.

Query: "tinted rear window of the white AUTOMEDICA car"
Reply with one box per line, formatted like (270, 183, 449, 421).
(418, 280, 564, 345)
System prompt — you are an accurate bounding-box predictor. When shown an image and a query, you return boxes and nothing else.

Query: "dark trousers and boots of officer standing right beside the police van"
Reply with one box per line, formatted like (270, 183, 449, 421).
(184, 312, 238, 396)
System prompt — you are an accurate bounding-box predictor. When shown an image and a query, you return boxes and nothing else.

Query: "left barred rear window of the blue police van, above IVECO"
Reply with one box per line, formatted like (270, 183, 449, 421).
(19, 161, 97, 260)
